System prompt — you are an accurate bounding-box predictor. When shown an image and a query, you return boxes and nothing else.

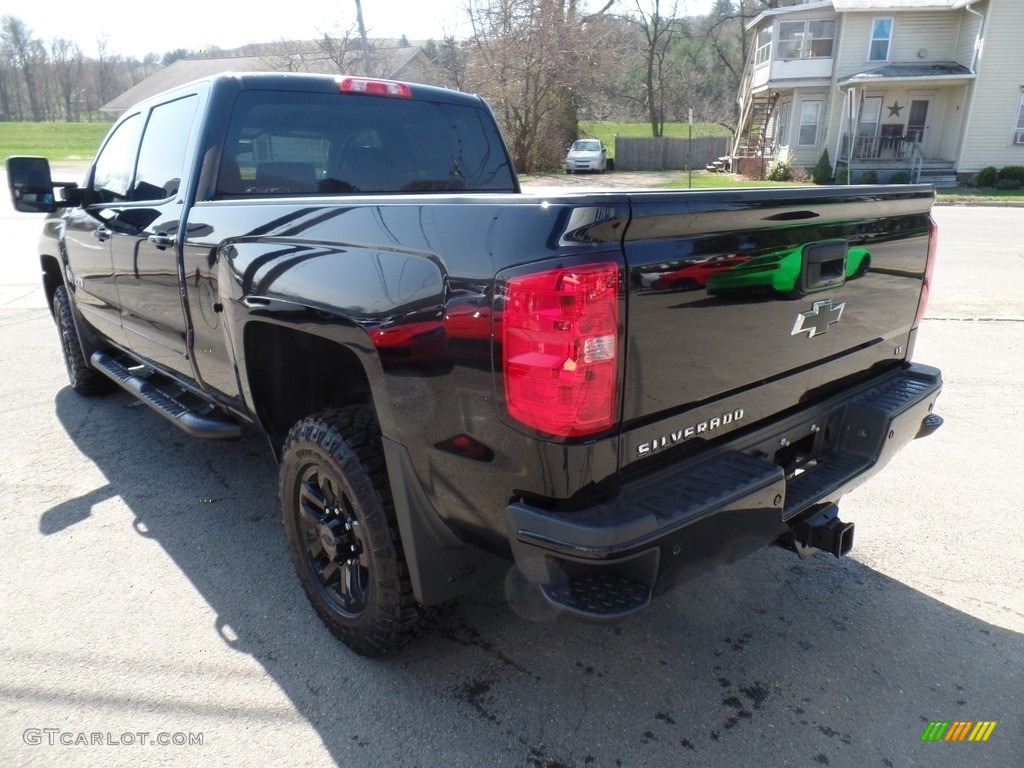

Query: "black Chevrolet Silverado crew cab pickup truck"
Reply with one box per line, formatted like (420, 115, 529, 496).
(7, 74, 941, 655)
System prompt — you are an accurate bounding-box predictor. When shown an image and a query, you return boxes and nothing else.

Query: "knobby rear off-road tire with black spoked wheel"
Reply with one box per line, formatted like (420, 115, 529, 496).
(281, 407, 428, 656)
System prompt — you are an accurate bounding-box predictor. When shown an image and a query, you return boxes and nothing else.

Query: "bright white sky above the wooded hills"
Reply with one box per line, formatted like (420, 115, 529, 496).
(0, 0, 713, 58)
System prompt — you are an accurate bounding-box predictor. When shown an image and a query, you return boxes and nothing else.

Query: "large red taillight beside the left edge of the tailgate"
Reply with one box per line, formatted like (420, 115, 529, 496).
(502, 262, 618, 437)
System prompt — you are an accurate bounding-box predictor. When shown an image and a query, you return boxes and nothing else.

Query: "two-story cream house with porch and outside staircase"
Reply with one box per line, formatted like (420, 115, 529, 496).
(733, 0, 1024, 186)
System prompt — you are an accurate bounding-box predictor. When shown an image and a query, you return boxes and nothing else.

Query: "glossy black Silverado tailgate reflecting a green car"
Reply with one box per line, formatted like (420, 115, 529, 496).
(621, 186, 934, 468)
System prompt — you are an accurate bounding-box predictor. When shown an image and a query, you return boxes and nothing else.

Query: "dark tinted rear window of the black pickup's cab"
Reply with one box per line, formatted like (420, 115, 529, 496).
(215, 91, 514, 200)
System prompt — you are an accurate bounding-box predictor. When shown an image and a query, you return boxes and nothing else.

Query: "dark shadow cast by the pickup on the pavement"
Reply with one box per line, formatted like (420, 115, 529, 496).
(51, 388, 1024, 768)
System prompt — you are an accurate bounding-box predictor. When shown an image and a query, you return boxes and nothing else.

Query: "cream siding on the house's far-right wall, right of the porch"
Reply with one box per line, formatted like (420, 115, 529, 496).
(957, 0, 1024, 173)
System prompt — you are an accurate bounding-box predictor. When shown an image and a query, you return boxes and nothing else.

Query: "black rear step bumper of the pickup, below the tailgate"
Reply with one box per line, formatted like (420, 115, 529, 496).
(506, 366, 942, 618)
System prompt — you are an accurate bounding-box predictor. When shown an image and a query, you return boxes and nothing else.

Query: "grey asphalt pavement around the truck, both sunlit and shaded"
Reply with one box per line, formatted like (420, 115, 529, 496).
(0, 177, 1024, 768)
